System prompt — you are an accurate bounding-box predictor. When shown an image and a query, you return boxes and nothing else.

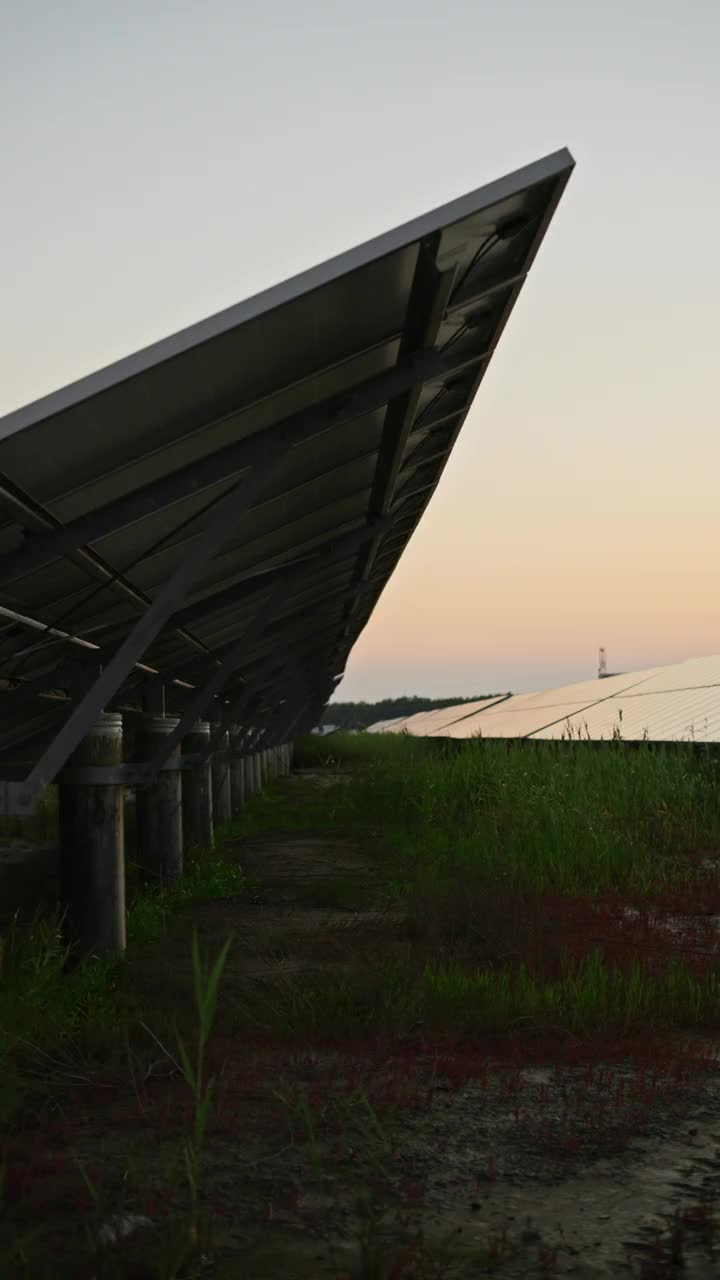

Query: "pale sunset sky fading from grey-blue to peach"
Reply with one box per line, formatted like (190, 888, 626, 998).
(0, 0, 720, 700)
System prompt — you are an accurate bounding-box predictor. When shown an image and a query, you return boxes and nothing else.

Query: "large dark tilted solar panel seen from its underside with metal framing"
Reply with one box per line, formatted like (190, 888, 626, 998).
(0, 151, 574, 813)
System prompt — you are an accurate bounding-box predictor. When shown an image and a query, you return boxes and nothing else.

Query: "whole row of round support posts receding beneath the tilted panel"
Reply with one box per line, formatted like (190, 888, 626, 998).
(58, 712, 292, 954)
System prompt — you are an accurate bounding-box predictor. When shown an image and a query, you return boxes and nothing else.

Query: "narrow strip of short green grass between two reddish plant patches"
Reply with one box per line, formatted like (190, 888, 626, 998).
(229, 948, 720, 1038)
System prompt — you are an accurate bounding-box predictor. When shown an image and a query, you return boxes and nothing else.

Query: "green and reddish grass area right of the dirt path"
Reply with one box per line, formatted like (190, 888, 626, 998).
(242, 733, 720, 1034)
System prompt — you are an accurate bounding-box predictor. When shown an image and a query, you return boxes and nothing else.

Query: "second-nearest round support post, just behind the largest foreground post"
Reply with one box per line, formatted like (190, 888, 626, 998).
(135, 714, 182, 884)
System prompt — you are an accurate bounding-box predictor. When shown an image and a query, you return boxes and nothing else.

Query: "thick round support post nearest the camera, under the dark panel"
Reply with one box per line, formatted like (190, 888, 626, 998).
(59, 713, 126, 955)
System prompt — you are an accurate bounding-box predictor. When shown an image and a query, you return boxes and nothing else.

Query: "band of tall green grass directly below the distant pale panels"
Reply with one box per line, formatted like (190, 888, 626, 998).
(310, 735, 720, 893)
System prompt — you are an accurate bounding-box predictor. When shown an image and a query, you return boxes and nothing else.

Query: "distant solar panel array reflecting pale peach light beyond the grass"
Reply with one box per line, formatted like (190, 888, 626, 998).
(369, 657, 720, 742)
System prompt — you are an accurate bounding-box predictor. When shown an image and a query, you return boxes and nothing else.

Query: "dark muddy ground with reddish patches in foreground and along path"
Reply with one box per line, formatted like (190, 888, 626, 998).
(5, 772, 720, 1280)
